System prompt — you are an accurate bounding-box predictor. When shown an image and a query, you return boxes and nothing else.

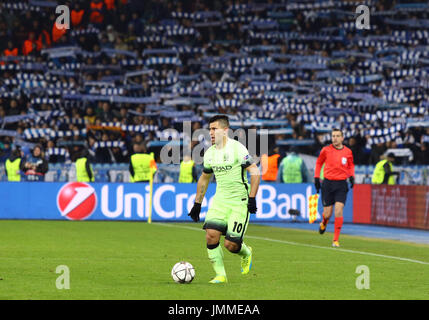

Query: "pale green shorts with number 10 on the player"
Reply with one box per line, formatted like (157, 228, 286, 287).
(203, 198, 249, 243)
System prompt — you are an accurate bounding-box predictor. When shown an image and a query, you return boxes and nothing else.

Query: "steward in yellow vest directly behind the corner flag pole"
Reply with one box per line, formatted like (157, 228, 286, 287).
(129, 143, 156, 182)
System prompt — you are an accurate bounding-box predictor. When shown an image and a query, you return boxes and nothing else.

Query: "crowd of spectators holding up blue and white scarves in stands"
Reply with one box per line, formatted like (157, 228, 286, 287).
(0, 0, 429, 169)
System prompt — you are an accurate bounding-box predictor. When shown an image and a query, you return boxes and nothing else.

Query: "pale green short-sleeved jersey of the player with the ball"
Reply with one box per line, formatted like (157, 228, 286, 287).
(204, 138, 253, 201)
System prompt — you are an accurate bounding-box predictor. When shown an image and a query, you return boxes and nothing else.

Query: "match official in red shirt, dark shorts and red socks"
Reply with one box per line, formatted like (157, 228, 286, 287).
(314, 129, 355, 247)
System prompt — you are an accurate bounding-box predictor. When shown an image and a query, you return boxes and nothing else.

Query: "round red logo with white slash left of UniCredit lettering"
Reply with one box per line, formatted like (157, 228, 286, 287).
(57, 182, 97, 220)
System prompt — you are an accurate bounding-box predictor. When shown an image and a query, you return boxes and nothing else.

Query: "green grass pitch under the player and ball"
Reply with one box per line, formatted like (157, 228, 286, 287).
(0, 220, 429, 300)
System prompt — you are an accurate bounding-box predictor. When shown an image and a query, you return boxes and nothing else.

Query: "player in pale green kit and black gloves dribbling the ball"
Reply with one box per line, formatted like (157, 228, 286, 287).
(189, 115, 260, 283)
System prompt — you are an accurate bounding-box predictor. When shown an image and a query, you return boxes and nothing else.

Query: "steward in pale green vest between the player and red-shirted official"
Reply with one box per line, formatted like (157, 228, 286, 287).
(278, 151, 308, 183)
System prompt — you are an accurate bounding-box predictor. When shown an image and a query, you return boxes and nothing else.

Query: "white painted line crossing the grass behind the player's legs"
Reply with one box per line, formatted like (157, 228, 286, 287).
(154, 223, 429, 265)
